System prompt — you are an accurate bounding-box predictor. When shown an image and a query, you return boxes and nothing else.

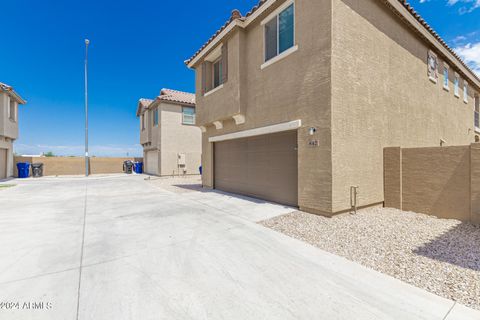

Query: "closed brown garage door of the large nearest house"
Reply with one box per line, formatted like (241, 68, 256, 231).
(214, 131, 298, 206)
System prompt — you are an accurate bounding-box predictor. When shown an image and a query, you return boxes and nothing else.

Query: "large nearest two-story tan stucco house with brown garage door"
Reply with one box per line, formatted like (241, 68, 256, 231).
(185, 0, 480, 215)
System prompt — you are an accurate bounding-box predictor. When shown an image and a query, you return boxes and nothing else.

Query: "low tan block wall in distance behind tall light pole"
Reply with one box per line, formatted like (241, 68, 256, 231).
(14, 157, 143, 176)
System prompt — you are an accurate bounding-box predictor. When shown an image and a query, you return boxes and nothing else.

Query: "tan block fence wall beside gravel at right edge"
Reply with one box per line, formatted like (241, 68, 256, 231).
(384, 144, 480, 223)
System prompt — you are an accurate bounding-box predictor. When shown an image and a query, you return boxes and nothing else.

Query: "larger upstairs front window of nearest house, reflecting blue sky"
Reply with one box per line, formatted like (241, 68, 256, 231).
(265, 3, 295, 62)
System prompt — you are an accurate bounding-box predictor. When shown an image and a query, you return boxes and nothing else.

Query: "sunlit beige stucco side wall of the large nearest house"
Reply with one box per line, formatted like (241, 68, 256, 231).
(332, 0, 474, 212)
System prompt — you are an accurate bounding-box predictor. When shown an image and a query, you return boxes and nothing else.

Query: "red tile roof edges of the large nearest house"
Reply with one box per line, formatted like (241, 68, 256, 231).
(185, 0, 480, 81)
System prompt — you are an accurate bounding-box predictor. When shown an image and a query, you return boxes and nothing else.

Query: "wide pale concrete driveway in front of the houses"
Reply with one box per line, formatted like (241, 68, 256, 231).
(0, 176, 480, 320)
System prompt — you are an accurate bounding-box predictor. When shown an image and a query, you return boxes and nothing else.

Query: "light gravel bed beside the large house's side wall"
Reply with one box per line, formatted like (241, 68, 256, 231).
(260, 208, 480, 309)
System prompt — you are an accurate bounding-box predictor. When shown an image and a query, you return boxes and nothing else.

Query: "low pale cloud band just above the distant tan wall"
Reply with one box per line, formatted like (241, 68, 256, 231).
(14, 143, 143, 157)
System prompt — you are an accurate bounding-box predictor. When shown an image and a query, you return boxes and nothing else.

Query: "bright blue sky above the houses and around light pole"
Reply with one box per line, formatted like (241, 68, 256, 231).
(0, 0, 480, 156)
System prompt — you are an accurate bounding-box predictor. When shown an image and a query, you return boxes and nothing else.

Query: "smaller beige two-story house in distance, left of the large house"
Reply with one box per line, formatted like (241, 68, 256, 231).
(137, 89, 202, 176)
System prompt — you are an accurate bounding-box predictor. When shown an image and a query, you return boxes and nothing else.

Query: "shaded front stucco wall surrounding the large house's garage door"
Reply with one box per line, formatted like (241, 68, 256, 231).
(196, 0, 331, 212)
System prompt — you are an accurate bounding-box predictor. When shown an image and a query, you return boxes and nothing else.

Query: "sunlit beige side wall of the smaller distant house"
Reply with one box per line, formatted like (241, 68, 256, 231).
(160, 103, 202, 175)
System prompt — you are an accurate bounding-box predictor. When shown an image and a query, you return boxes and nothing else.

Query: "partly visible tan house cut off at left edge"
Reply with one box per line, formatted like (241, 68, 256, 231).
(0, 82, 26, 179)
